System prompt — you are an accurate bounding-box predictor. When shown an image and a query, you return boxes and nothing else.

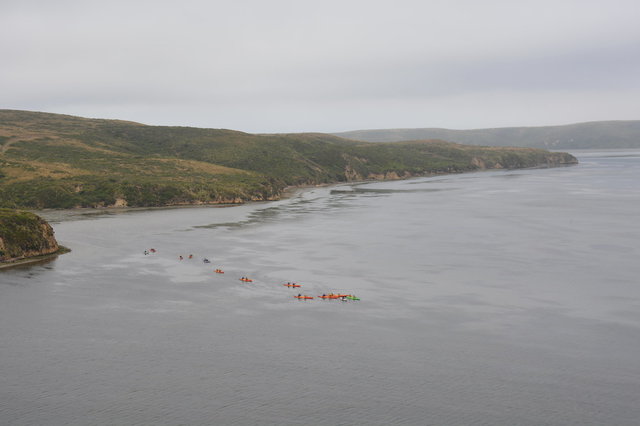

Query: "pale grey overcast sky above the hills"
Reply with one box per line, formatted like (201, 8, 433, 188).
(0, 0, 640, 132)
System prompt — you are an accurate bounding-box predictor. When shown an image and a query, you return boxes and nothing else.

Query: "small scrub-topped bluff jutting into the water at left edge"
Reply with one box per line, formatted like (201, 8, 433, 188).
(0, 209, 61, 266)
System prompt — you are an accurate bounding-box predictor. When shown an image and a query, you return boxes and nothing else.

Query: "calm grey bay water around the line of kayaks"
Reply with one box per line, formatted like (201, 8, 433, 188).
(0, 151, 640, 426)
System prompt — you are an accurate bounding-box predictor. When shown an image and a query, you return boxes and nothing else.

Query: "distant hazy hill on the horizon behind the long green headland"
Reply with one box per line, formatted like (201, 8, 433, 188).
(335, 121, 640, 150)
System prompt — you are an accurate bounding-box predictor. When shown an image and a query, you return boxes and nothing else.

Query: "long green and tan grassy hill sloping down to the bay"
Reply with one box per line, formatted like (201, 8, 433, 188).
(0, 110, 575, 208)
